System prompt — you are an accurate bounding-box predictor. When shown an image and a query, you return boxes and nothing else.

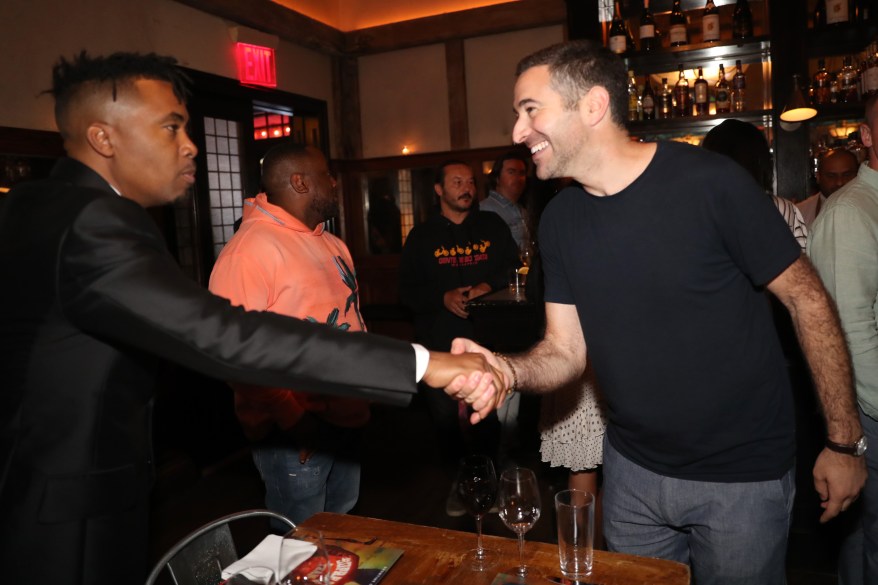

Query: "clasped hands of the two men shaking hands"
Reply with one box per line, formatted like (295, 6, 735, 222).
(422, 339, 513, 424)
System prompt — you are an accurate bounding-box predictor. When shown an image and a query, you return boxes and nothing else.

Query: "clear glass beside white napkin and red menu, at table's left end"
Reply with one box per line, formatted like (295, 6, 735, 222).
(277, 527, 332, 585)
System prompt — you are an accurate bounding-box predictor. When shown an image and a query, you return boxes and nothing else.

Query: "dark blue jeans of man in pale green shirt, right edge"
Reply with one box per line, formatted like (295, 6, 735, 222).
(838, 410, 878, 585)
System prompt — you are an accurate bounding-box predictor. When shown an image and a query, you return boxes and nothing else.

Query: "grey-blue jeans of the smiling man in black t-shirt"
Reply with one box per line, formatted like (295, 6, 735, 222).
(603, 439, 795, 585)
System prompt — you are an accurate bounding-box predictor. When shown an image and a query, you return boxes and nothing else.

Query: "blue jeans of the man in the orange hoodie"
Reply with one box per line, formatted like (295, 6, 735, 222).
(253, 425, 360, 527)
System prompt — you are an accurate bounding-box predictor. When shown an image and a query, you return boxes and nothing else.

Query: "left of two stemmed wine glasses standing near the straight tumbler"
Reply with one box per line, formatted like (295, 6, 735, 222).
(457, 455, 497, 571)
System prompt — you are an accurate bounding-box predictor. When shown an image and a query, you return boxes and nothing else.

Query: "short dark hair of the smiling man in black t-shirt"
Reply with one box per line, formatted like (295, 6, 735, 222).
(515, 40, 628, 127)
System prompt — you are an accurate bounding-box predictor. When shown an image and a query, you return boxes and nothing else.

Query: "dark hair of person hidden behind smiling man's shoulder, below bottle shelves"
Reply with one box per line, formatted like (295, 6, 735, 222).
(701, 118, 774, 194)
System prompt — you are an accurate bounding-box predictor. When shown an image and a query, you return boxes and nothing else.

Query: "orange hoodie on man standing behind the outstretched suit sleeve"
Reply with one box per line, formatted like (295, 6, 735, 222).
(209, 193, 369, 440)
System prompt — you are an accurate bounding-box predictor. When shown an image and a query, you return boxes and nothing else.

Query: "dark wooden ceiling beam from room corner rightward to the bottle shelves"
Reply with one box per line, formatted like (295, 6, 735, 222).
(345, 0, 567, 55)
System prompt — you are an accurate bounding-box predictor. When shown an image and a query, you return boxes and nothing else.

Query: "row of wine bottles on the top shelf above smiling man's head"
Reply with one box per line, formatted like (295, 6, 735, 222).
(607, 0, 753, 55)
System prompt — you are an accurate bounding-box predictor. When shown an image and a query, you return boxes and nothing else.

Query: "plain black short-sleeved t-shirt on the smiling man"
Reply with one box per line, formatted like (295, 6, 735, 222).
(540, 143, 800, 482)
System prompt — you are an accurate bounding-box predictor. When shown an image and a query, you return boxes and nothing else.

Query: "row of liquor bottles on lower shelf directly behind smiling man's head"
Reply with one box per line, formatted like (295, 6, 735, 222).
(628, 60, 747, 121)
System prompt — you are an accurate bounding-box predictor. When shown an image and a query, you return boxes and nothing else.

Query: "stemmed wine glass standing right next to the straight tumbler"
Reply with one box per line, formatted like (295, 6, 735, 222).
(499, 467, 540, 577)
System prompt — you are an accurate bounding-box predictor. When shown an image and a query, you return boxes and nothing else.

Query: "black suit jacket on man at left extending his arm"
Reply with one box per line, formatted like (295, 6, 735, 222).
(0, 159, 416, 584)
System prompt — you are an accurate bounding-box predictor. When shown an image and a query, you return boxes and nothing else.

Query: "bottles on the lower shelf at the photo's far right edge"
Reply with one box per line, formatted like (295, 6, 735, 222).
(808, 42, 878, 106)
